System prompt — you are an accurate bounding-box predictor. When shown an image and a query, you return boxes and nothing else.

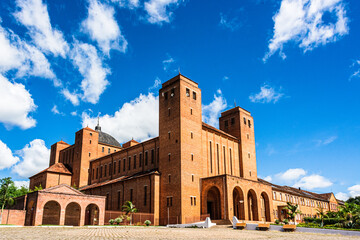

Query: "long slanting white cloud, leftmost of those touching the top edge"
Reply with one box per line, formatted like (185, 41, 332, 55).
(14, 0, 69, 58)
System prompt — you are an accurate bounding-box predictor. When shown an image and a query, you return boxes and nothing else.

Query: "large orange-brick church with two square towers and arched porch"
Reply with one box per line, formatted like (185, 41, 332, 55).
(30, 74, 339, 225)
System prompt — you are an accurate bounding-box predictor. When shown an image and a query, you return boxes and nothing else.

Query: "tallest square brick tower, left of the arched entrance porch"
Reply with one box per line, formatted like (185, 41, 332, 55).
(159, 74, 203, 224)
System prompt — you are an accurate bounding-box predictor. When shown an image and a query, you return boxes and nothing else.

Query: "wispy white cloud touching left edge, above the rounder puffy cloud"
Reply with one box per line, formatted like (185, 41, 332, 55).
(0, 26, 56, 81)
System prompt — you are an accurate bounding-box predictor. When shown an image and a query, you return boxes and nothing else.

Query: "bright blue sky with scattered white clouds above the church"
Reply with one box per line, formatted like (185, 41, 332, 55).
(0, 0, 360, 199)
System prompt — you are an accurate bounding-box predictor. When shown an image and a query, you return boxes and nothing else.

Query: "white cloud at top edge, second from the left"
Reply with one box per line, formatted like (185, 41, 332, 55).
(82, 0, 128, 55)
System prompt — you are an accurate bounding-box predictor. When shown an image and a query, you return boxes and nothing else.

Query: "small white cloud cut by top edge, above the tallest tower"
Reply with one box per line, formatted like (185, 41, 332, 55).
(144, 0, 183, 25)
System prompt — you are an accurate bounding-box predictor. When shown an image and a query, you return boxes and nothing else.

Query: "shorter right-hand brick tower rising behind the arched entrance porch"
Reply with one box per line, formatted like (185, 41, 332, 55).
(219, 107, 257, 181)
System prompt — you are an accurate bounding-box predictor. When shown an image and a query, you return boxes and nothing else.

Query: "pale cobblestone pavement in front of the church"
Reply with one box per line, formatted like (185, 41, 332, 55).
(0, 226, 360, 240)
